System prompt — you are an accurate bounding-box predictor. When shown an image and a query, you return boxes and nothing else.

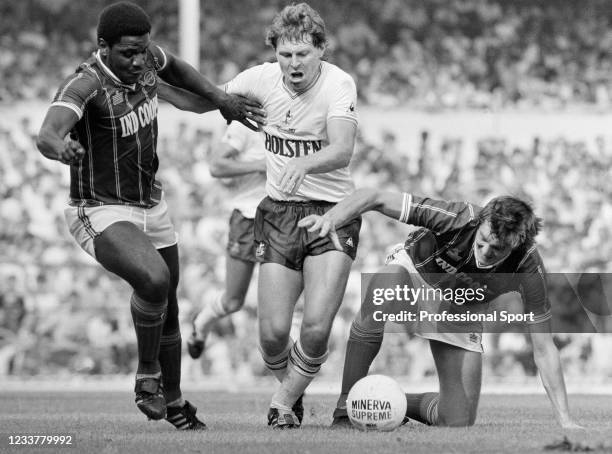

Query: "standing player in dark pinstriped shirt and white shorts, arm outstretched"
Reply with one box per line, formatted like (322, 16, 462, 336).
(37, 2, 265, 429)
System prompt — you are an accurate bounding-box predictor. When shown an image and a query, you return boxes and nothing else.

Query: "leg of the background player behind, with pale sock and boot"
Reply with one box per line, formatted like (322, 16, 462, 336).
(187, 254, 255, 359)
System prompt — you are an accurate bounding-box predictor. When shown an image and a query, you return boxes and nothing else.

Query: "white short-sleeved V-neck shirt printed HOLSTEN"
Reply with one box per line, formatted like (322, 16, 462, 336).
(225, 62, 357, 202)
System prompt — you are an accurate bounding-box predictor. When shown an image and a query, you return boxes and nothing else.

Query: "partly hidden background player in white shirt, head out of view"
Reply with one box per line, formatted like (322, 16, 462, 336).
(187, 122, 266, 359)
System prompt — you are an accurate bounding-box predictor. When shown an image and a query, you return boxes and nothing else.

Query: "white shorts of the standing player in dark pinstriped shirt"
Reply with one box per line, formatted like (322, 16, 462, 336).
(64, 196, 178, 258)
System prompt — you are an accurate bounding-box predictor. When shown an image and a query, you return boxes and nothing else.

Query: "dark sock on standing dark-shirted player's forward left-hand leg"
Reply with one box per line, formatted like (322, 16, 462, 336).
(130, 293, 167, 374)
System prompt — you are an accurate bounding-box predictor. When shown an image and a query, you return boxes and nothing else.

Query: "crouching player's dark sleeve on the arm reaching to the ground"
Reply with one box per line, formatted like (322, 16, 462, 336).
(517, 245, 552, 324)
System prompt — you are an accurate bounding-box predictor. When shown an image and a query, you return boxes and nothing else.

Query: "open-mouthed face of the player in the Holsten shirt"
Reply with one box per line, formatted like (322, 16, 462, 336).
(276, 36, 324, 91)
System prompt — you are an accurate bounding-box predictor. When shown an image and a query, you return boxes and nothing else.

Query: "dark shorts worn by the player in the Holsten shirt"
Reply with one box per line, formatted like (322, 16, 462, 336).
(255, 197, 361, 271)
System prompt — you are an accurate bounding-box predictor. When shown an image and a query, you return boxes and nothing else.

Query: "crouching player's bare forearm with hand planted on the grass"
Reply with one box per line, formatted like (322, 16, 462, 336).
(529, 321, 582, 429)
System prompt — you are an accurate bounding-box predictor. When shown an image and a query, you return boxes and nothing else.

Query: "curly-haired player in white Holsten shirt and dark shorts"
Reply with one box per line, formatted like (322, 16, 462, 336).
(225, 3, 361, 428)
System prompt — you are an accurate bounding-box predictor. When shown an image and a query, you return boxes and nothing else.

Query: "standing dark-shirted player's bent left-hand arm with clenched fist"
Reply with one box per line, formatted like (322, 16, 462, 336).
(36, 106, 85, 164)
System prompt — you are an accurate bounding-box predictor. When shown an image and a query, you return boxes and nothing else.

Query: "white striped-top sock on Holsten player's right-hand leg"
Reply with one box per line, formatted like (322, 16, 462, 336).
(270, 339, 329, 409)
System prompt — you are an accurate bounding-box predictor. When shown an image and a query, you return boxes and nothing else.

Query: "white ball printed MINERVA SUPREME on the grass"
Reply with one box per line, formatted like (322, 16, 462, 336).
(346, 375, 406, 432)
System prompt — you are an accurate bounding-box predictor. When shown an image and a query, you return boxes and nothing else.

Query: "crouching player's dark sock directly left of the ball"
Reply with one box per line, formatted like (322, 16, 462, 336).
(336, 321, 384, 408)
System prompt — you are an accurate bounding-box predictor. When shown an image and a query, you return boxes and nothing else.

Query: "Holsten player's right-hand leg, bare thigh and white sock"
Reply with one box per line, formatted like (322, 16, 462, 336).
(272, 251, 352, 426)
